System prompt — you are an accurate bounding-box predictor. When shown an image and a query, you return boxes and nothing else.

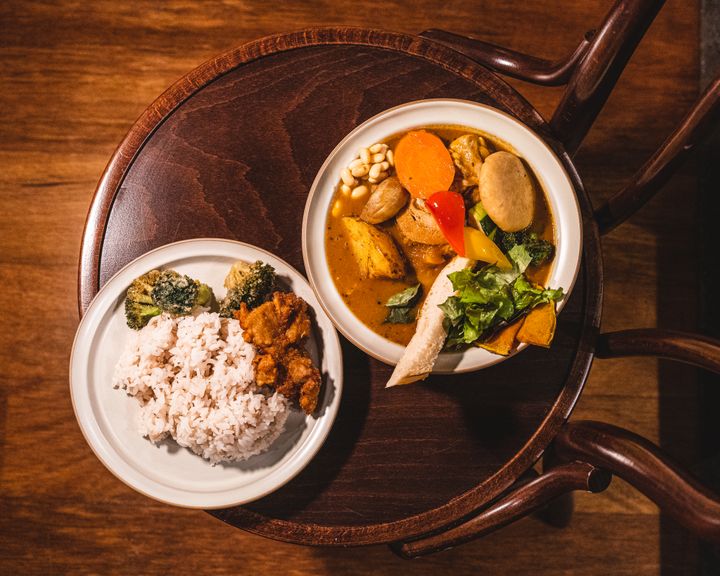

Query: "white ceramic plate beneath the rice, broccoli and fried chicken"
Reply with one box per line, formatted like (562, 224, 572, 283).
(70, 239, 342, 508)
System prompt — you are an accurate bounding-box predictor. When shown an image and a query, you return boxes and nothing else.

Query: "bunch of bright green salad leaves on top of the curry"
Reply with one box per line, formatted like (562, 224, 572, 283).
(440, 264, 563, 348)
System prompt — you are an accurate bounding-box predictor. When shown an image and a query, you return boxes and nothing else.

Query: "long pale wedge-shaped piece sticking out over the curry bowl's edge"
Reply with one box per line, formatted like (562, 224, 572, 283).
(385, 256, 475, 388)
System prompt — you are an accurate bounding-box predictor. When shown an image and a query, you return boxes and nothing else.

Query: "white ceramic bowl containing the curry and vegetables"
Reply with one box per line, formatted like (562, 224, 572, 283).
(302, 99, 582, 373)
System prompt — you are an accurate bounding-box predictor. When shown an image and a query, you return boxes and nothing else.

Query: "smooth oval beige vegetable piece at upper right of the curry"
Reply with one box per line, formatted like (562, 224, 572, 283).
(478, 152, 535, 232)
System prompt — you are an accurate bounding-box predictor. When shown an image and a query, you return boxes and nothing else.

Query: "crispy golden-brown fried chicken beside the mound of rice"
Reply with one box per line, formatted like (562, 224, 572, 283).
(235, 292, 322, 414)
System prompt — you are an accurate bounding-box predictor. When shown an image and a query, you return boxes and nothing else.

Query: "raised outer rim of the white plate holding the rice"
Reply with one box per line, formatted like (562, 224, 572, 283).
(68, 237, 344, 510)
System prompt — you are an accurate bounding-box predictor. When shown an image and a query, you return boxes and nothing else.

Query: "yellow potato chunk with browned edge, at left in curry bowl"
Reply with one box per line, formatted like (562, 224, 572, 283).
(341, 216, 405, 278)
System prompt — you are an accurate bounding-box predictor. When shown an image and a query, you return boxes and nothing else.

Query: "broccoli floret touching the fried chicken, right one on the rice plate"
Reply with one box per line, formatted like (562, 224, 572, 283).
(220, 260, 277, 318)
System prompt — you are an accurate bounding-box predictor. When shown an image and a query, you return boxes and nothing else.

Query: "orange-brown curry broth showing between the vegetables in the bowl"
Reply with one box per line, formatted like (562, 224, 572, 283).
(325, 126, 555, 345)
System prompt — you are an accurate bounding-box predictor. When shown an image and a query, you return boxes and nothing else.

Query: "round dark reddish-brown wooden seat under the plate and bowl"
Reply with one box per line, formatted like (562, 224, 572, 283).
(79, 28, 602, 545)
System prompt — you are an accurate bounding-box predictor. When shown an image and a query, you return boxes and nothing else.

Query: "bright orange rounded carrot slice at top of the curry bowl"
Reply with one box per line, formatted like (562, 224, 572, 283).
(395, 130, 455, 198)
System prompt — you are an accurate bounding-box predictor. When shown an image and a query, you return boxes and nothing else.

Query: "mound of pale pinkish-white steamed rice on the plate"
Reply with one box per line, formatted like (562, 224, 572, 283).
(112, 312, 290, 464)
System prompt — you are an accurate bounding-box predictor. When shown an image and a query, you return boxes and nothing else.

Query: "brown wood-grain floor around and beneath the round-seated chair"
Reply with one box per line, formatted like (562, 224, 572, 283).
(0, 1, 699, 574)
